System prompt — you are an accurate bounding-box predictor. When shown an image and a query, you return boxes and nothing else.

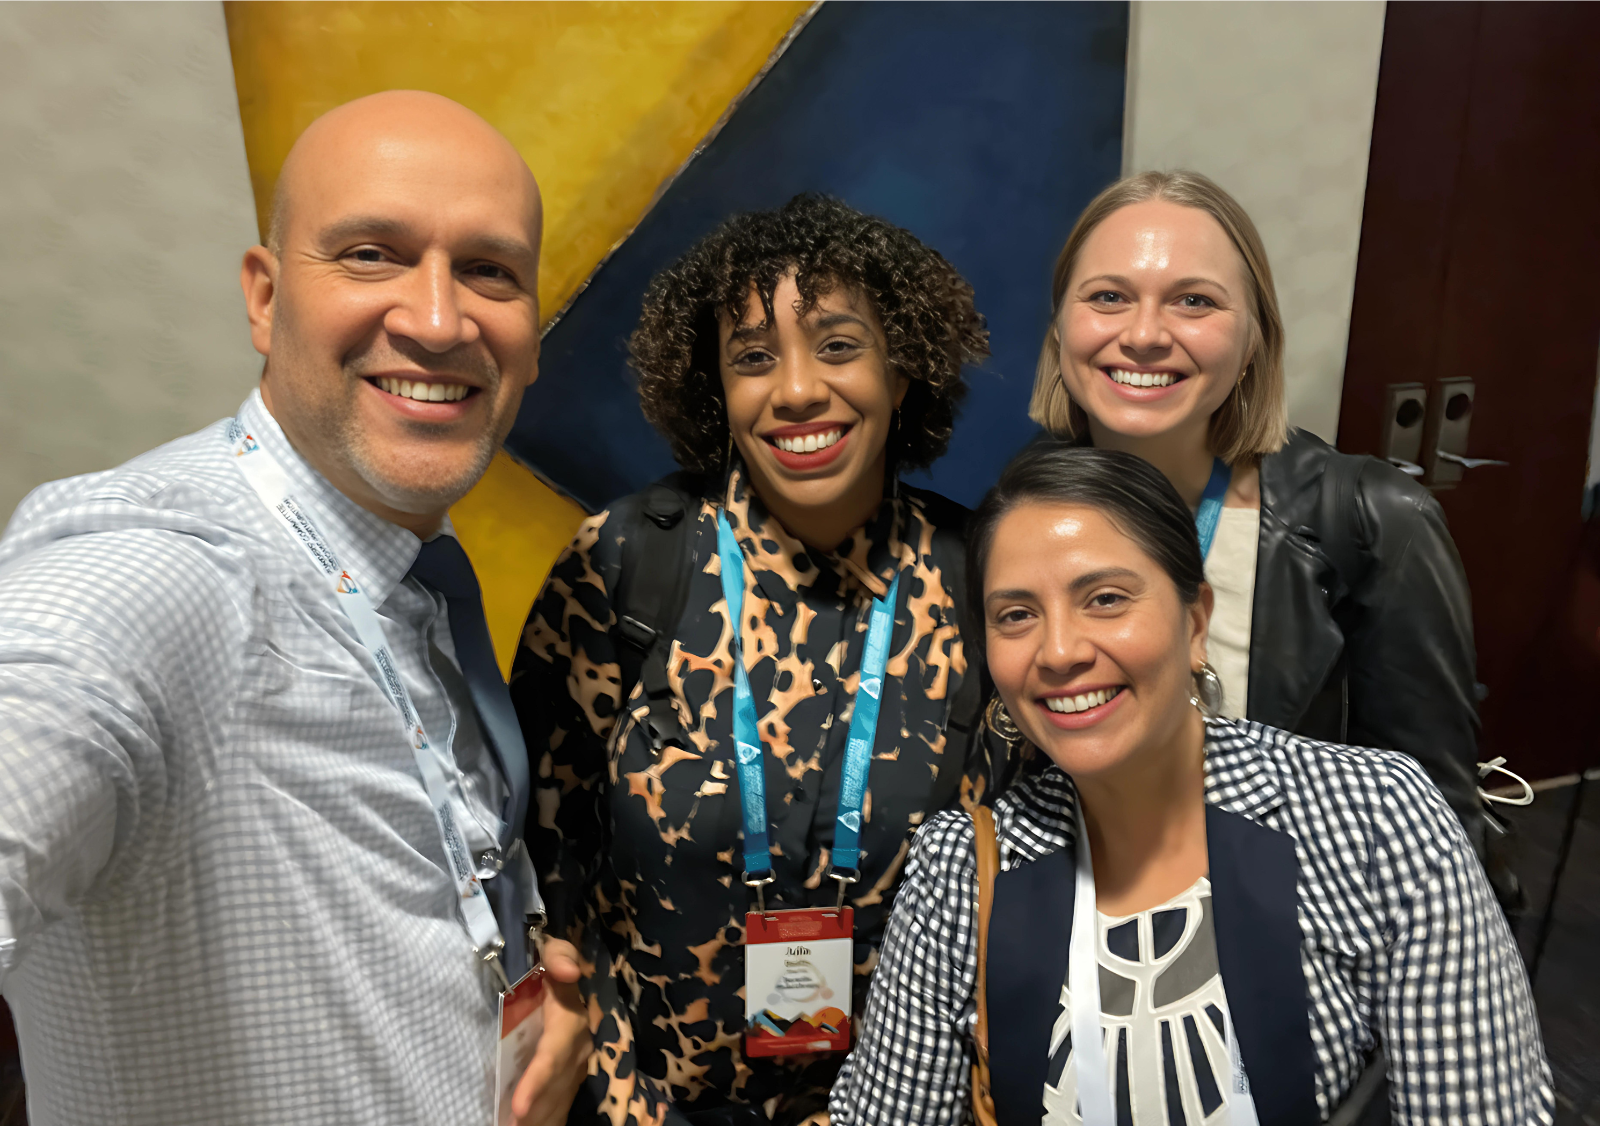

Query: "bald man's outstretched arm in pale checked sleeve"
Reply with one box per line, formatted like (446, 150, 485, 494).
(0, 529, 248, 984)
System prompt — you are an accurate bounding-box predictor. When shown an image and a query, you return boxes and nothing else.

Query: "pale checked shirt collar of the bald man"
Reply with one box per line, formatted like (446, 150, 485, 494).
(238, 389, 428, 606)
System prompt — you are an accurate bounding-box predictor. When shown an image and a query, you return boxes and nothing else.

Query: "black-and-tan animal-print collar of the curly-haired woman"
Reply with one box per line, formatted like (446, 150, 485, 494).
(723, 464, 917, 598)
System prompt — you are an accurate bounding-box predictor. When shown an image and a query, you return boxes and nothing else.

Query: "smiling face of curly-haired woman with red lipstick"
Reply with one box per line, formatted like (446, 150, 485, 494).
(718, 274, 909, 549)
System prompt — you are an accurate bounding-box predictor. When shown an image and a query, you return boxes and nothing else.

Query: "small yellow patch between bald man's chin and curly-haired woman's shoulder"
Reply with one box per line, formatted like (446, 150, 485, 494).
(450, 454, 586, 675)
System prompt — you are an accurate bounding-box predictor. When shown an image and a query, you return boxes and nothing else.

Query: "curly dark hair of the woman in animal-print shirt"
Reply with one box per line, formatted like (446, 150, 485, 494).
(629, 192, 989, 473)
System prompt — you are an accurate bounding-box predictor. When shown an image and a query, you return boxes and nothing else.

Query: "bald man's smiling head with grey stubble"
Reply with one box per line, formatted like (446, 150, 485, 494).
(243, 93, 541, 534)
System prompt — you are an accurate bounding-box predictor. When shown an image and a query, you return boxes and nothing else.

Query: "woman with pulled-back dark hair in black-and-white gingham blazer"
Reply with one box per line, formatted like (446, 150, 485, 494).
(830, 445, 1554, 1126)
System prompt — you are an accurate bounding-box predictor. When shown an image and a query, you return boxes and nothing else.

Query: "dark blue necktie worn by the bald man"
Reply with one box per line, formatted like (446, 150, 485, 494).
(411, 536, 528, 980)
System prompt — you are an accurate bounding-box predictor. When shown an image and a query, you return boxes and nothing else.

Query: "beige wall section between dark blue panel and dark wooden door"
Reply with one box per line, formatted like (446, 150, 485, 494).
(1123, 0, 1384, 440)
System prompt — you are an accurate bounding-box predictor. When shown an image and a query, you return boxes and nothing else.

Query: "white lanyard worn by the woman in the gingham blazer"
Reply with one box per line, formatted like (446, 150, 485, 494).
(1067, 798, 1259, 1126)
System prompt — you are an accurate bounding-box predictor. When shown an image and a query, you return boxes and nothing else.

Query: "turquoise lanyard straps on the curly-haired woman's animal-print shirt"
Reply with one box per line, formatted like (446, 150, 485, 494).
(717, 512, 899, 899)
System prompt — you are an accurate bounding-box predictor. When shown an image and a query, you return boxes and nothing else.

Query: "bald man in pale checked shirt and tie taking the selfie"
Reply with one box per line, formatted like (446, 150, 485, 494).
(0, 91, 587, 1126)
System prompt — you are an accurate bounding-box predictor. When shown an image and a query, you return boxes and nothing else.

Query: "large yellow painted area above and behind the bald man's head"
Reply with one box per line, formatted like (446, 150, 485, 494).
(224, 0, 810, 326)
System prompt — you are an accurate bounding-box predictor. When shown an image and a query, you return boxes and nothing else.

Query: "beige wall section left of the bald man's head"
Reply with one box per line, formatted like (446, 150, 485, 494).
(0, 2, 261, 521)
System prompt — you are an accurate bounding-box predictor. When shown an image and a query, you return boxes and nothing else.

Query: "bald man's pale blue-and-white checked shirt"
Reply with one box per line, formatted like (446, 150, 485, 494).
(0, 395, 504, 1126)
